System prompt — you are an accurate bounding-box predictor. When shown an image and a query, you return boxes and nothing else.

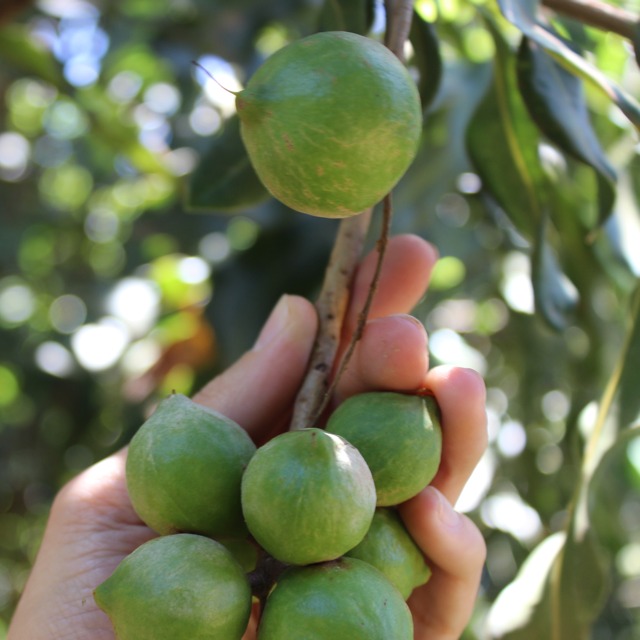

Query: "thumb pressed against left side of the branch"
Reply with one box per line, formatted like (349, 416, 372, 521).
(193, 296, 317, 440)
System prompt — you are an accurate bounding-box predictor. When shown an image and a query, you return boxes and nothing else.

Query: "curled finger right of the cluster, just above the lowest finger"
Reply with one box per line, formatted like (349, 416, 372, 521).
(424, 366, 487, 504)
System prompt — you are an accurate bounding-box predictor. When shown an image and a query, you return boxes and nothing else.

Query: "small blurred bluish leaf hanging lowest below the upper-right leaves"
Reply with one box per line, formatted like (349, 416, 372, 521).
(531, 218, 578, 331)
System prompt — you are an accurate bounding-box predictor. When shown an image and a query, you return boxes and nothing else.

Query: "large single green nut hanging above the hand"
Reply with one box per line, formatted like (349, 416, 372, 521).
(236, 31, 422, 218)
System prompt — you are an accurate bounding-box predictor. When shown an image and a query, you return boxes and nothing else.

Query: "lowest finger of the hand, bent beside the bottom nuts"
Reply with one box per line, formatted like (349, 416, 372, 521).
(400, 486, 486, 640)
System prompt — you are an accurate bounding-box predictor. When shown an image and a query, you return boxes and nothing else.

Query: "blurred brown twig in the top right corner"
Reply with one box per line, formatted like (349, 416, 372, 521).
(542, 0, 640, 40)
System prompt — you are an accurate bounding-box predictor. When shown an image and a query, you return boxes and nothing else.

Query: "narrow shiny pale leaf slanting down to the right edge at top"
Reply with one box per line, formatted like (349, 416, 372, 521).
(498, 0, 640, 128)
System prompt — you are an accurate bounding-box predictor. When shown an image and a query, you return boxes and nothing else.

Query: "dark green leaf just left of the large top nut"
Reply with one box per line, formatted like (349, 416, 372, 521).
(186, 116, 269, 212)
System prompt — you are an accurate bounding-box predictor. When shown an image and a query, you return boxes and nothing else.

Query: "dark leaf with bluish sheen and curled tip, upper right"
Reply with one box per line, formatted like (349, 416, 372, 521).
(518, 38, 616, 224)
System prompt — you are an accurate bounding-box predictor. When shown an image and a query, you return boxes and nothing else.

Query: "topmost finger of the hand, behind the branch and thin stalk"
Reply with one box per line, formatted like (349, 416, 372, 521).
(343, 234, 438, 339)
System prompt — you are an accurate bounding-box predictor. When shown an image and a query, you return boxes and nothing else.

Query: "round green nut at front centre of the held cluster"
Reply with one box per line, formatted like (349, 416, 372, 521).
(242, 429, 376, 565)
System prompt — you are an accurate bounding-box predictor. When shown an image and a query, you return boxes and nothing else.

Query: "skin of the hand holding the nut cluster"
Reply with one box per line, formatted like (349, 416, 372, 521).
(8, 235, 487, 640)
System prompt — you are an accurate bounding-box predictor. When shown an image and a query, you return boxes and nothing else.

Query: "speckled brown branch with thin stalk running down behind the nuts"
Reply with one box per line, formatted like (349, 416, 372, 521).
(289, 0, 413, 431)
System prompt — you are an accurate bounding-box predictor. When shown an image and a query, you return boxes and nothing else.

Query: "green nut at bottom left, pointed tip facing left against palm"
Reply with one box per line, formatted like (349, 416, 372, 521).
(94, 533, 251, 640)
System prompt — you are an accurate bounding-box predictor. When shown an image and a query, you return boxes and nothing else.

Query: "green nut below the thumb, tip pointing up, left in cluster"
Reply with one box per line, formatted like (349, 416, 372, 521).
(126, 394, 256, 538)
